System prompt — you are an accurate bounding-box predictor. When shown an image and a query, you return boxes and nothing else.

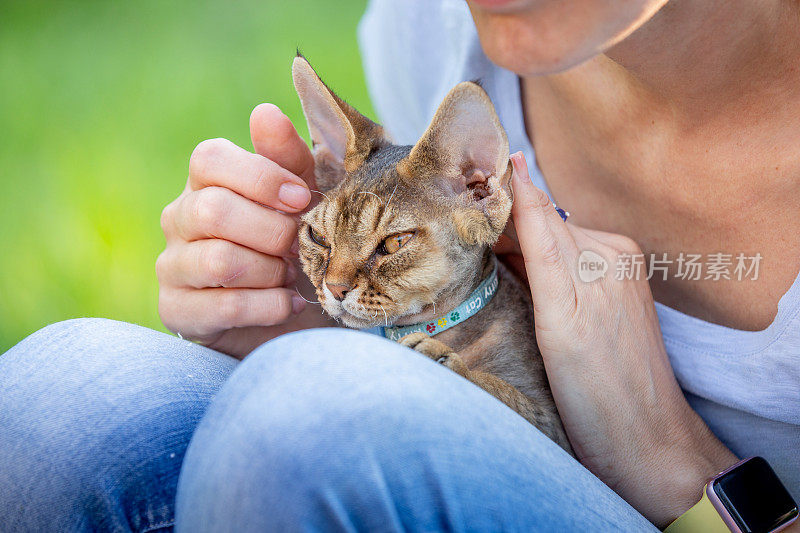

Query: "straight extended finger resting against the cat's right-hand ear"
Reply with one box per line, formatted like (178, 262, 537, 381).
(511, 154, 575, 310)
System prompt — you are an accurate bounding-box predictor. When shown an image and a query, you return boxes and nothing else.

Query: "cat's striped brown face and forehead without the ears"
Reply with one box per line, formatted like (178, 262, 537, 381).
(299, 146, 483, 328)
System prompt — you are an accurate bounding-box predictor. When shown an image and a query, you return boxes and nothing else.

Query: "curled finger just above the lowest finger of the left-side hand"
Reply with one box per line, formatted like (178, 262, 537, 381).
(156, 239, 297, 289)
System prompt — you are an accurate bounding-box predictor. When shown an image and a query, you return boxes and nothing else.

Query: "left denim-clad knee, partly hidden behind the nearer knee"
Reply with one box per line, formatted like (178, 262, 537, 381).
(0, 319, 235, 529)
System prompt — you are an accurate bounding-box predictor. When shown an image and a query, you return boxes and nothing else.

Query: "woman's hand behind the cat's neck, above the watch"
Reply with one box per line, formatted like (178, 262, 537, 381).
(512, 153, 737, 527)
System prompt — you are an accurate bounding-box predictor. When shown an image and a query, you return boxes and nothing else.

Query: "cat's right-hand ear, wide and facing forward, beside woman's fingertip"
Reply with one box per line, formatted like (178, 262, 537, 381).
(397, 82, 512, 244)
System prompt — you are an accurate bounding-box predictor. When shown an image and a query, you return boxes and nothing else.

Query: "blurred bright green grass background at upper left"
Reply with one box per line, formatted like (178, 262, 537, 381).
(0, 0, 372, 353)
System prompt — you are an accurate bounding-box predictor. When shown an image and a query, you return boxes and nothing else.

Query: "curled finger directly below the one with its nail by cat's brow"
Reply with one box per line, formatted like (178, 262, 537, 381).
(175, 187, 297, 257)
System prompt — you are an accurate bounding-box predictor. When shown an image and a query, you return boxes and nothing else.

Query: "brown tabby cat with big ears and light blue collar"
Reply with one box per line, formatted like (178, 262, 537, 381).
(292, 54, 572, 453)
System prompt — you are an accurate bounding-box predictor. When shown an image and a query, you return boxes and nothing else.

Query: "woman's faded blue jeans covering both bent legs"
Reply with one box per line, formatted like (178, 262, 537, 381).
(0, 319, 657, 532)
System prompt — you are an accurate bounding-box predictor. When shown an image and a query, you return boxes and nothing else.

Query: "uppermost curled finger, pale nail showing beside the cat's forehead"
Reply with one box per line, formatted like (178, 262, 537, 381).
(189, 139, 311, 212)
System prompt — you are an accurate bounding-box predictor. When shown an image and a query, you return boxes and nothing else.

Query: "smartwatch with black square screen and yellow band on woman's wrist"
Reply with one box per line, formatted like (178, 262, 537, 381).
(664, 457, 797, 533)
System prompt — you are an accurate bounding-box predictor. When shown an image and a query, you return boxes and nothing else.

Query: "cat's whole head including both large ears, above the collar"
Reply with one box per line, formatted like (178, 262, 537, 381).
(293, 57, 511, 328)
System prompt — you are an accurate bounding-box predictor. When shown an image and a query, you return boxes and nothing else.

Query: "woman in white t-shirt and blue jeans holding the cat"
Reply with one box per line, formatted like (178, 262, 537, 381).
(0, 0, 800, 531)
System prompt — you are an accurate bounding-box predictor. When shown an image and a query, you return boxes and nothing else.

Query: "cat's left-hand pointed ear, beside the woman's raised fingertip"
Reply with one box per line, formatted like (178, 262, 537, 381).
(292, 54, 389, 190)
